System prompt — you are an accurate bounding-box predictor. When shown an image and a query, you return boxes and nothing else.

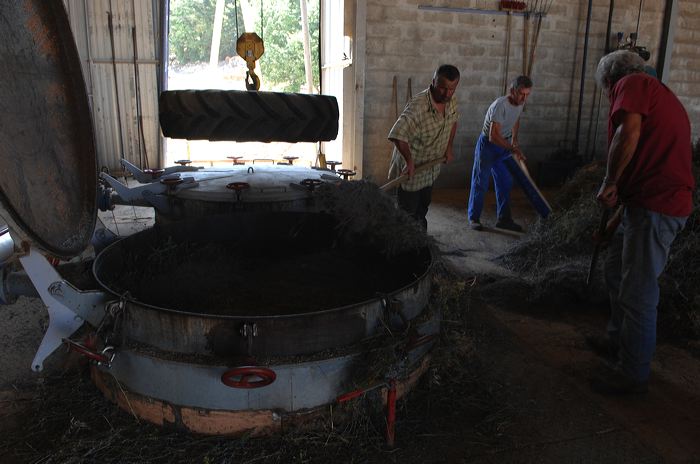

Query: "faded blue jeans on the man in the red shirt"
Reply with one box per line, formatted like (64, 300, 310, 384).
(605, 207, 687, 382)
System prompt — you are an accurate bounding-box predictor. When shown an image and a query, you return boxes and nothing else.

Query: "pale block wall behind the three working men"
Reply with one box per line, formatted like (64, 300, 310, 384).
(363, 0, 700, 187)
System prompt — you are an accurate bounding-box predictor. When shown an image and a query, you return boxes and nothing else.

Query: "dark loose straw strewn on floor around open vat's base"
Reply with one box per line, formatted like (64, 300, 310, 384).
(0, 265, 516, 464)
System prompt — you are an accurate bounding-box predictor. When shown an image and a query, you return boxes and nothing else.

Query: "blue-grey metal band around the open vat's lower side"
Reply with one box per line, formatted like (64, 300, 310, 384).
(88, 318, 440, 423)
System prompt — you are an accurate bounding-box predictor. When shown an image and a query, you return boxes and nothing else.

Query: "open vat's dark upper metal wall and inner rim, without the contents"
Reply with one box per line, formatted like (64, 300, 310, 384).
(94, 212, 432, 358)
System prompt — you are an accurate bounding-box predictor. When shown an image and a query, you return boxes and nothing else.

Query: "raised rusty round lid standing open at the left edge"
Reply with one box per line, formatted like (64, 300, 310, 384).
(0, 0, 97, 258)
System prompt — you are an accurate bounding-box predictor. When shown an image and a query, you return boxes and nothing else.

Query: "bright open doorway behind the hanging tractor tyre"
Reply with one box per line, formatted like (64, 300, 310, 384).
(165, 0, 328, 167)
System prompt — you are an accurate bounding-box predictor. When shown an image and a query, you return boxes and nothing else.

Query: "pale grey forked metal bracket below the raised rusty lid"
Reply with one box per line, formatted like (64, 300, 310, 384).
(19, 247, 105, 372)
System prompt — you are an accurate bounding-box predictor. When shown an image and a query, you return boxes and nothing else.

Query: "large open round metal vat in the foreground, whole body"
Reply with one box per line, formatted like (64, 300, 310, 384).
(88, 212, 439, 434)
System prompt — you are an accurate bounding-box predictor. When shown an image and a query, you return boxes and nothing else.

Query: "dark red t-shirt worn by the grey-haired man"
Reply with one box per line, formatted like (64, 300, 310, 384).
(608, 73, 695, 216)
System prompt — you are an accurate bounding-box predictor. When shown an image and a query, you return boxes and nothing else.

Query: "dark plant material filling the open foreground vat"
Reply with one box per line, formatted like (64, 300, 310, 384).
(102, 214, 427, 316)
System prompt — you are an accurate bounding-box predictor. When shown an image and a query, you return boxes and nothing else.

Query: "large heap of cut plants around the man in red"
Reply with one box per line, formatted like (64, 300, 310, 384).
(501, 139, 700, 340)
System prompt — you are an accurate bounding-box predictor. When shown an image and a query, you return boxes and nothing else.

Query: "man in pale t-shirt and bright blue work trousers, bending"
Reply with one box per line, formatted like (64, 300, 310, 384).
(467, 76, 532, 232)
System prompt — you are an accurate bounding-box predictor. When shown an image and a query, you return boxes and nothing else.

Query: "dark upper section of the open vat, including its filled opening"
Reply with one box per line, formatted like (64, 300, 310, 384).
(94, 212, 432, 357)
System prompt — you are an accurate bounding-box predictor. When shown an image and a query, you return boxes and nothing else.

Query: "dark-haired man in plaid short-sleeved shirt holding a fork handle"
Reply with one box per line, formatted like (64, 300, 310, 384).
(388, 64, 459, 229)
